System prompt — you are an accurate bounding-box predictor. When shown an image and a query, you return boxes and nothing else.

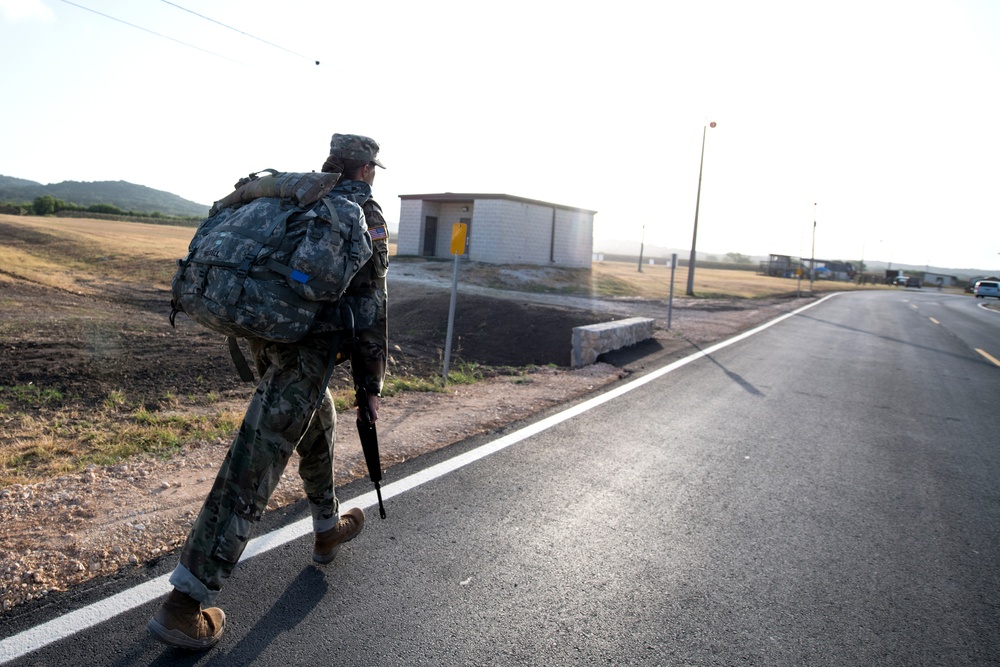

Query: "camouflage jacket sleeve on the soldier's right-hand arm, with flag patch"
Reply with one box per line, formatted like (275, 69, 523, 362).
(345, 199, 389, 395)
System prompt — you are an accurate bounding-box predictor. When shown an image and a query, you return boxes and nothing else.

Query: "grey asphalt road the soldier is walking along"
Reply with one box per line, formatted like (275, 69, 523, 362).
(0, 290, 1000, 665)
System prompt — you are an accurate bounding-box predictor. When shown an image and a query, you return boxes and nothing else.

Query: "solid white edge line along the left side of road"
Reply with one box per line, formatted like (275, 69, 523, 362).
(0, 292, 842, 664)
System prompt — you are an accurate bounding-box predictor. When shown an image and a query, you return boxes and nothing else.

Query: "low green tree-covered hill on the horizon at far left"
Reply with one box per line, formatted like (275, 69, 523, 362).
(0, 175, 209, 217)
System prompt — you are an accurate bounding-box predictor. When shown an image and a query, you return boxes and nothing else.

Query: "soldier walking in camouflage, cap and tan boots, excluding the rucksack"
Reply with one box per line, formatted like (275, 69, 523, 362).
(148, 134, 389, 649)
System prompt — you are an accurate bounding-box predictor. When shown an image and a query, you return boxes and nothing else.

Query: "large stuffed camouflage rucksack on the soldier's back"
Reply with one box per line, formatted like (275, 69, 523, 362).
(170, 169, 373, 348)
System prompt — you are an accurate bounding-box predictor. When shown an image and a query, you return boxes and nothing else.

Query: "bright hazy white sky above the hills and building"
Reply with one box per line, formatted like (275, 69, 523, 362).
(0, 0, 1000, 271)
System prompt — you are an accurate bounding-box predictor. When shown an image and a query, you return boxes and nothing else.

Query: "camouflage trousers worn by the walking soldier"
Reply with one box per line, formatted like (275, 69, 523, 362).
(170, 340, 339, 603)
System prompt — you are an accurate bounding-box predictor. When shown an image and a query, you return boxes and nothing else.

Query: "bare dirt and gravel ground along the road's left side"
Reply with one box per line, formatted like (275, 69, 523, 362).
(0, 217, 816, 613)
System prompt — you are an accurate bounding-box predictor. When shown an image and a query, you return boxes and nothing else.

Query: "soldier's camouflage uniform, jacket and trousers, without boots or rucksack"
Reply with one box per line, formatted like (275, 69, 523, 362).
(170, 135, 389, 604)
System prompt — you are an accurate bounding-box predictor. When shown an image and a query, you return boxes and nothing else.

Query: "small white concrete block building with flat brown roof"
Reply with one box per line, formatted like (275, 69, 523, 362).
(396, 192, 597, 269)
